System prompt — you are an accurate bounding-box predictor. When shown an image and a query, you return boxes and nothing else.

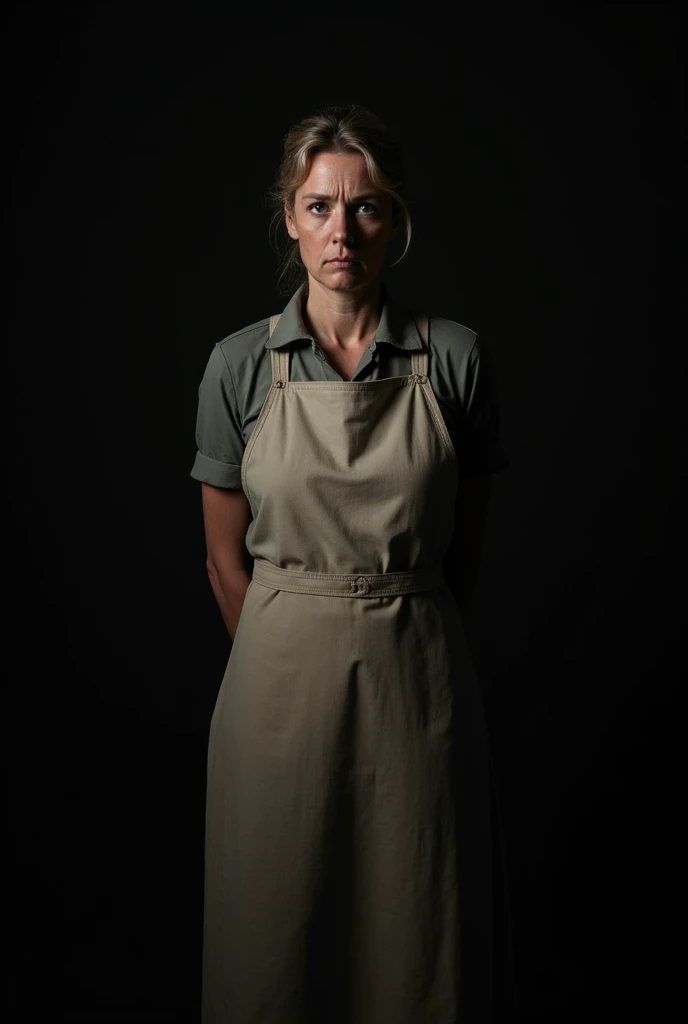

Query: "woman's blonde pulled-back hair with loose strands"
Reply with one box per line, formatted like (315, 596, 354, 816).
(267, 103, 411, 295)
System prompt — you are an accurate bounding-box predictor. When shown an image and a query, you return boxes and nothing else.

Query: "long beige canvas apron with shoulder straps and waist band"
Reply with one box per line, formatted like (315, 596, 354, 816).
(203, 316, 511, 1024)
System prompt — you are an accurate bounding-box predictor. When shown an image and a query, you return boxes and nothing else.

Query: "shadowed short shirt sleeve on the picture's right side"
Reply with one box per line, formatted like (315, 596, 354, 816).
(458, 336, 509, 477)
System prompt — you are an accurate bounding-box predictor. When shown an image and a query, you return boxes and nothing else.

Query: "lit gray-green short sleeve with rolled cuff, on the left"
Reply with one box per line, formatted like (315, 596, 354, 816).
(190, 344, 245, 487)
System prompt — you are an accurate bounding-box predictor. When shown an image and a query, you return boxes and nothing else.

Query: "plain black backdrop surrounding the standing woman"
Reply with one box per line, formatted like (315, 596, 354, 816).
(3, 3, 685, 1024)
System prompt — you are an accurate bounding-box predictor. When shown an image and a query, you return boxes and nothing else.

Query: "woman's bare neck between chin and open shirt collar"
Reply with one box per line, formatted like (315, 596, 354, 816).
(301, 278, 383, 349)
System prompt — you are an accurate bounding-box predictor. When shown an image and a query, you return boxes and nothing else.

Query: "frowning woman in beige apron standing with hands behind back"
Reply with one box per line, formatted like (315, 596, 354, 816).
(191, 105, 511, 1024)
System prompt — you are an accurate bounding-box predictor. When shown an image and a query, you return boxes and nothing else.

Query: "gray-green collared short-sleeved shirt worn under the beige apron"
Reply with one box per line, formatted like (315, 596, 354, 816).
(190, 284, 508, 487)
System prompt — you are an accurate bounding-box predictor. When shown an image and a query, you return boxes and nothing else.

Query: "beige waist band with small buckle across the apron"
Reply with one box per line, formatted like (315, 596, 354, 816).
(253, 558, 444, 597)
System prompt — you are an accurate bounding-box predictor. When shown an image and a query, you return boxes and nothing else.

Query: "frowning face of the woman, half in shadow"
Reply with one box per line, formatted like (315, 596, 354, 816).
(285, 153, 398, 292)
